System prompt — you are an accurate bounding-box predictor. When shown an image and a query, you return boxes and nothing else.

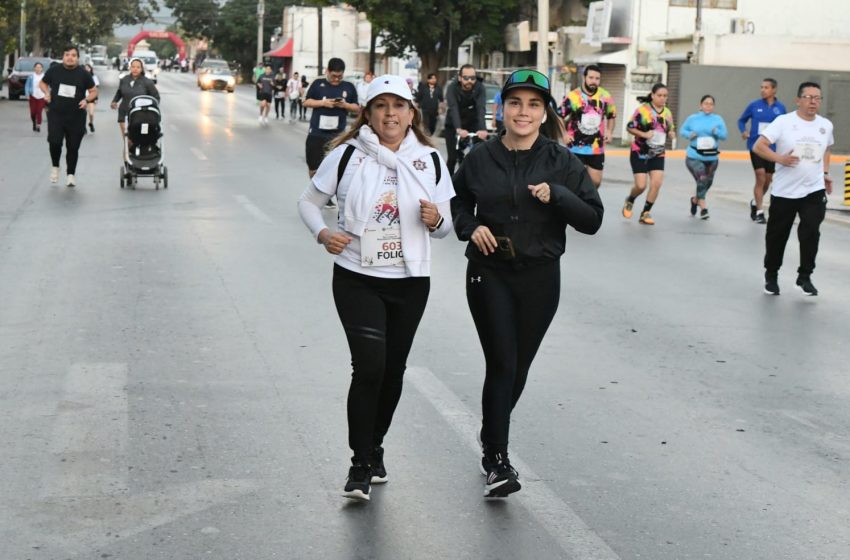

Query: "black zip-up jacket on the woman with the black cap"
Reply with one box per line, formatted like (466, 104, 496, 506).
(452, 135, 604, 269)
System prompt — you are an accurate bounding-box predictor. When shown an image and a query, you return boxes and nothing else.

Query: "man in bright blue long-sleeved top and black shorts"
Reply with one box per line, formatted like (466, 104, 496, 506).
(738, 78, 788, 224)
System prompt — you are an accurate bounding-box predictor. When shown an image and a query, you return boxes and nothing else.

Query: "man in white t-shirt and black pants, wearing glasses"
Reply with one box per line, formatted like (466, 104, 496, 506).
(753, 82, 834, 296)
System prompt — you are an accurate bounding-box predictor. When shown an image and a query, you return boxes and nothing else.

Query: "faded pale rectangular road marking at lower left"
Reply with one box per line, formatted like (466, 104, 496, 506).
(42, 363, 129, 497)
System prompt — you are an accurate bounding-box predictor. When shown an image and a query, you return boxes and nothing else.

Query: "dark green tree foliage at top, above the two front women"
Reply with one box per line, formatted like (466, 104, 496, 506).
(349, 0, 518, 80)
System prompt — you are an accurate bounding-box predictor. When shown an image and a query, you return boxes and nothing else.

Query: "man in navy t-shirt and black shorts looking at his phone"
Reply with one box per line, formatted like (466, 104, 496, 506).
(304, 58, 360, 206)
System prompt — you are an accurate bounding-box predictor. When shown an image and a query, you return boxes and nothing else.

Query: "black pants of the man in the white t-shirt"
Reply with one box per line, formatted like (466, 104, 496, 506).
(764, 190, 826, 277)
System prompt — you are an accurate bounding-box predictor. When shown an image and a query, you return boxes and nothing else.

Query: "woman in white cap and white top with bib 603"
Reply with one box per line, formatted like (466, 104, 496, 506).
(298, 75, 454, 500)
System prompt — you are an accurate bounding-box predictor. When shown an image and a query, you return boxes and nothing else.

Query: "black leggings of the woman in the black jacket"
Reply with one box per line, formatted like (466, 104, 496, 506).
(466, 260, 561, 453)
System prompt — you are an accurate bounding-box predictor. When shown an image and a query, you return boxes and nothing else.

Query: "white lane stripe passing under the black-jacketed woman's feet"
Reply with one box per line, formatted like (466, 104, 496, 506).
(405, 367, 620, 560)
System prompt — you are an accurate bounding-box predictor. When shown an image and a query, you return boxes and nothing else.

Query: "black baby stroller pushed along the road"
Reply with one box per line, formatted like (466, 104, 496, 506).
(120, 95, 168, 190)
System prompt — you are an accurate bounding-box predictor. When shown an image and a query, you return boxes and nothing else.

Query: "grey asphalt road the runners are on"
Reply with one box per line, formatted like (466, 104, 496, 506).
(0, 74, 850, 560)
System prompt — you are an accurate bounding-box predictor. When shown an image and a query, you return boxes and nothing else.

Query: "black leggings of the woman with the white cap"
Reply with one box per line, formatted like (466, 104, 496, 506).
(333, 265, 431, 463)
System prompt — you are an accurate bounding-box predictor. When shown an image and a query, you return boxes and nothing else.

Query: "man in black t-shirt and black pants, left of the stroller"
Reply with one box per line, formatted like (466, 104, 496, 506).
(38, 47, 97, 187)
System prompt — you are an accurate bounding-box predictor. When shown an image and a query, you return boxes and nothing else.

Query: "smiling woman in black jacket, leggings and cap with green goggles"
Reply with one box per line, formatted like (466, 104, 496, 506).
(452, 70, 603, 497)
